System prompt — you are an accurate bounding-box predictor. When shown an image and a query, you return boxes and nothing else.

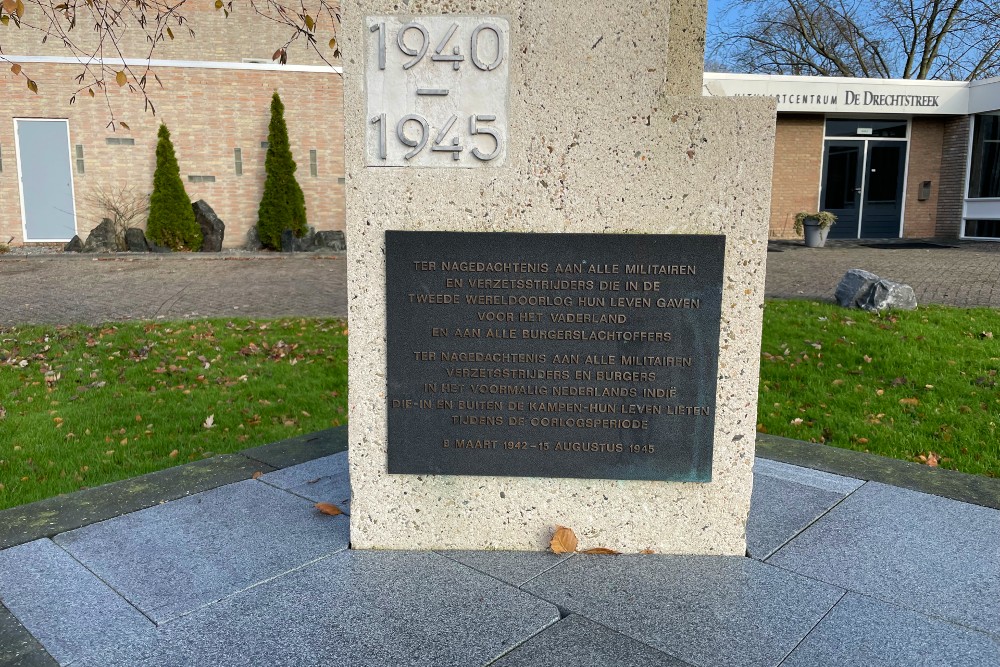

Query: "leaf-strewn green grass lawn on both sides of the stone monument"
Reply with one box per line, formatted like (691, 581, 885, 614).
(0, 301, 1000, 508)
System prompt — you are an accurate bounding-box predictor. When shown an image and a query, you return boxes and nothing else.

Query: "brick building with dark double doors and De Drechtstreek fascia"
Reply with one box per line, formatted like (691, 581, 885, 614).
(704, 73, 1000, 239)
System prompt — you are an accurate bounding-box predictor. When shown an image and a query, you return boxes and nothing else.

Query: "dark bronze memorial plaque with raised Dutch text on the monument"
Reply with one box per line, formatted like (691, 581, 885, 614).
(385, 231, 728, 482)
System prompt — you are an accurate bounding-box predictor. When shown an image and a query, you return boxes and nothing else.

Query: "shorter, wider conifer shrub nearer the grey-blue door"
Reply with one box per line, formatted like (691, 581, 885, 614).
(146, 124, 201, 250)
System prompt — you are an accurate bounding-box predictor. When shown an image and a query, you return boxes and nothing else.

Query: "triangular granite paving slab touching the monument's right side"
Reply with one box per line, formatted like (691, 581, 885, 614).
(747, 459, 864, 560)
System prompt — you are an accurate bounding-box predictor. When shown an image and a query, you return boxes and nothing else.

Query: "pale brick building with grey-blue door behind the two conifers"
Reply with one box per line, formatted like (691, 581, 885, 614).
(0, 2, 344, 247)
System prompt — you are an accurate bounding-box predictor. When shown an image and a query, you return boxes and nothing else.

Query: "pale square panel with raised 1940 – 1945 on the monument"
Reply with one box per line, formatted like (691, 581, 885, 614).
(365, 16, 510, 168)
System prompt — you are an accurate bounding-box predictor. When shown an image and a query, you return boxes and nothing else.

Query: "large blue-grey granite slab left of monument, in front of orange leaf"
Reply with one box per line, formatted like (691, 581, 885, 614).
(55, 480, 348, 623)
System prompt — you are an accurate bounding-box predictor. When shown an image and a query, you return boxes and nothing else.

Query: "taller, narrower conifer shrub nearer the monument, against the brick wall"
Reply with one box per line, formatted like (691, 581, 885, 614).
(257, 93, 309, 250)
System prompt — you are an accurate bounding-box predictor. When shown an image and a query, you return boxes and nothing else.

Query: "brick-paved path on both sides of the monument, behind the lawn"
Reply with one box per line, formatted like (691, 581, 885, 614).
(0, 241, 1000, 326)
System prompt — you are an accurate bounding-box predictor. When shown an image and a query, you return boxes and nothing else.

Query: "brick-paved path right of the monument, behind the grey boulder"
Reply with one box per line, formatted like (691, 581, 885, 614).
(765, 240, 1000, 308)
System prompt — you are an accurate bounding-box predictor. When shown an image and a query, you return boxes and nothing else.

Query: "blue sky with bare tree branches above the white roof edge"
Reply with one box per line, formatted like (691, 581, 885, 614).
(707, 0, 1000, 79)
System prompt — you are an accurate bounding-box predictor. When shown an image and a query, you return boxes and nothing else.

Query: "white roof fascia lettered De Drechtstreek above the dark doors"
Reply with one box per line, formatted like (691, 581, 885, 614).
(704, 73, 969, 115)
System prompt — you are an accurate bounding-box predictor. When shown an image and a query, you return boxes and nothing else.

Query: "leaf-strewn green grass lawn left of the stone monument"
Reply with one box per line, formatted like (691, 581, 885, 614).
(0, 318, 347, 508)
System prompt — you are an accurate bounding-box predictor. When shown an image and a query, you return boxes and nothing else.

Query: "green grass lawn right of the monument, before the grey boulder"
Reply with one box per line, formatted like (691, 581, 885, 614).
(757, 301, 1000, 477)
